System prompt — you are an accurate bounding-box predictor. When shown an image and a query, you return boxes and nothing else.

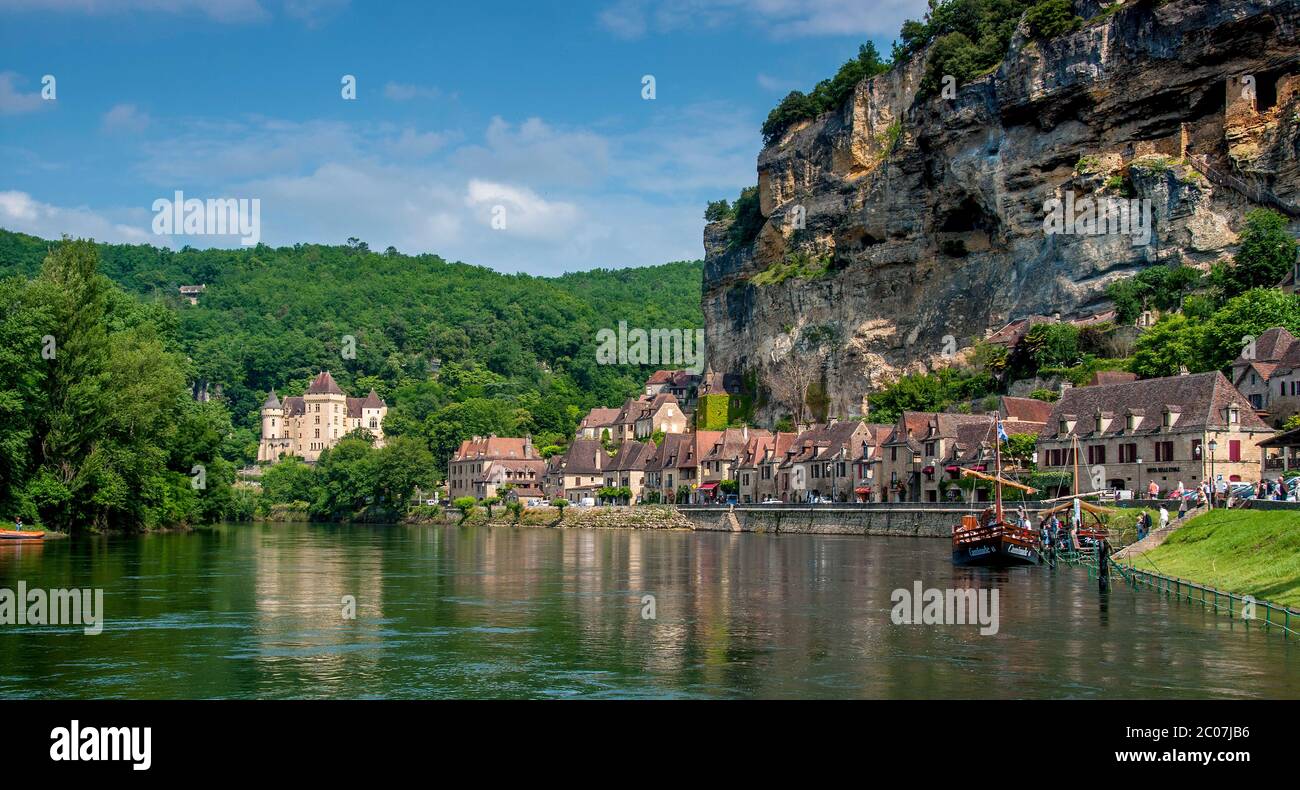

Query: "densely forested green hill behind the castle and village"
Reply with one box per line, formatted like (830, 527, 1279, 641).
(0, 230, 702, 457)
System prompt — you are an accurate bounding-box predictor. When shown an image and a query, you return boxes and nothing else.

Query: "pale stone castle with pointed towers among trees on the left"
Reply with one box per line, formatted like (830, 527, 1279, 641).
(257, 370, 389, 463)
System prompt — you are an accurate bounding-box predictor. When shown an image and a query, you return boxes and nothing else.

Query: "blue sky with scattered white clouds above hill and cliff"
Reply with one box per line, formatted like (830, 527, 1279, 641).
(0, 0, 924, 274)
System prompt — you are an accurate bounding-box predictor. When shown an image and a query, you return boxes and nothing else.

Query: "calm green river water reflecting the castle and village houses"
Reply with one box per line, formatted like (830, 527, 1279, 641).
(0, 524, 1300, 699)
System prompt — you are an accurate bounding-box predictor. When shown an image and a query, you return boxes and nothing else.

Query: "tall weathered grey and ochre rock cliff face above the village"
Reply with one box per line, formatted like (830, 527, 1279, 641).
(703, 0, 1300, 417)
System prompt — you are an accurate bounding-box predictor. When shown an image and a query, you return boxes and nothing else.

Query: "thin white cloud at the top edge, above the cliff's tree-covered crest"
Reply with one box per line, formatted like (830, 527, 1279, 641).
(597, 0, 928, 39)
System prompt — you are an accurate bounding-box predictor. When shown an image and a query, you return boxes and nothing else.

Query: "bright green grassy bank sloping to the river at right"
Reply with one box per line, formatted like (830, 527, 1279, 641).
(1130, 511, 1300, 608)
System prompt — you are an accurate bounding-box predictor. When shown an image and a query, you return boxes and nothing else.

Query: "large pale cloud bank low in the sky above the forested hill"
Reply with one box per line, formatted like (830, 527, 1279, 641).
(10, 100, 759, 274)
